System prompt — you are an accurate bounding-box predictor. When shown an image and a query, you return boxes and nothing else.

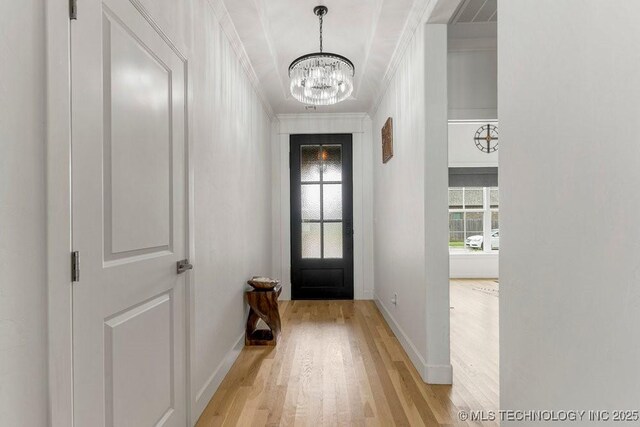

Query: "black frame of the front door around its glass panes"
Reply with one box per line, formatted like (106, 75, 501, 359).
(289, 133, 354, 300)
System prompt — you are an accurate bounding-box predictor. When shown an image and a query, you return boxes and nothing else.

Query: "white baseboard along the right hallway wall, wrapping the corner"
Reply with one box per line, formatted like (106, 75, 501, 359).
(374, 295, 453, 384)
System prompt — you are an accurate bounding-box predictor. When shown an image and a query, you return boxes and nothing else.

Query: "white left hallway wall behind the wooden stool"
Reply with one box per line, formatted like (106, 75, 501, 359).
(189, 1, 271, 422)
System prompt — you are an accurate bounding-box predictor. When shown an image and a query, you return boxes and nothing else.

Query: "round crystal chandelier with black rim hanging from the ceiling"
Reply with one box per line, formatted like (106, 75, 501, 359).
(289, 6, 355, 105)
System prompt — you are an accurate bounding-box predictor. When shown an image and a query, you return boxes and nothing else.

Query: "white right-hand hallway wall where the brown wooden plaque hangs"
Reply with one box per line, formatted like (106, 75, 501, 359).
(372, 25, 451, 383)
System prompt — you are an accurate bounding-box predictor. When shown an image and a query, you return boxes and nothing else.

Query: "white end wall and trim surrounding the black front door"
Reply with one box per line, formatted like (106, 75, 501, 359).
(271, 113, 373, 300)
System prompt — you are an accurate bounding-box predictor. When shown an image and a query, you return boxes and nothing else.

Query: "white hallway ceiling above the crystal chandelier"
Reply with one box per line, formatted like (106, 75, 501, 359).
(213, 0, 429, 114)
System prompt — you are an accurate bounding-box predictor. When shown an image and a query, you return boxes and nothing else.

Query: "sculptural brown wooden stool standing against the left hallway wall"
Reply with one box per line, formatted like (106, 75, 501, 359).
(244, 285, 282, 345)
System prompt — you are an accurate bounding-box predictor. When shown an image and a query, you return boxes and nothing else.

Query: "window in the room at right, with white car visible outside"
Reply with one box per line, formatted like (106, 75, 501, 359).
(449, 187, 500, 253)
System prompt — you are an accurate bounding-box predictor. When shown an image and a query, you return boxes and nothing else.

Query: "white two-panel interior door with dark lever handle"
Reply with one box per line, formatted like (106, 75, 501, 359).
(71, 0, 187, 427)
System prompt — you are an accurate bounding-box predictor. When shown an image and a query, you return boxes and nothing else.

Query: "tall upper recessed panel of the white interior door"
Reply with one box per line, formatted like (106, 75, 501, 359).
(103, 11, 171, 254)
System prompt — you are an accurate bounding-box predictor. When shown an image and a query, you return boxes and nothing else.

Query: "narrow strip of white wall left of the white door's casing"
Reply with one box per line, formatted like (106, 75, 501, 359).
(0, 0, 47, 426)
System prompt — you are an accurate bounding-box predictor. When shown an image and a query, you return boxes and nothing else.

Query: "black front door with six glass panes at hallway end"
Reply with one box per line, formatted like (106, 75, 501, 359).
(290, 134, 353, 299)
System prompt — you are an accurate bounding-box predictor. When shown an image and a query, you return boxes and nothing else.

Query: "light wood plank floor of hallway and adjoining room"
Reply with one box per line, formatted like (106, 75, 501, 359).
(197, 281, 498, 427)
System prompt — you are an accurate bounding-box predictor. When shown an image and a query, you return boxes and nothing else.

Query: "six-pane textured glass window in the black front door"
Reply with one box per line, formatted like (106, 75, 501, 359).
(300, 145, 343, 259)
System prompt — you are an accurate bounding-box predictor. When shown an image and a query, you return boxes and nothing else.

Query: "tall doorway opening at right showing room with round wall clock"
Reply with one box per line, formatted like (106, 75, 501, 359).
(447, 0, 500, 418)
